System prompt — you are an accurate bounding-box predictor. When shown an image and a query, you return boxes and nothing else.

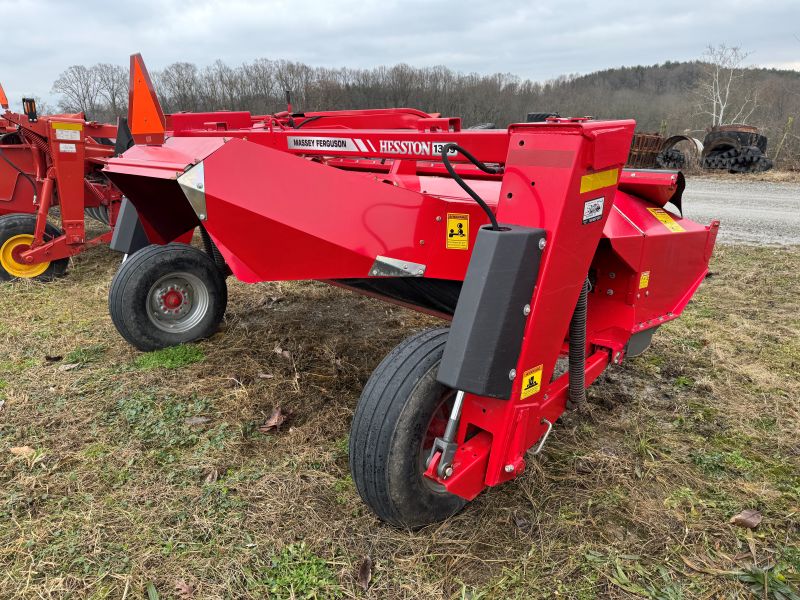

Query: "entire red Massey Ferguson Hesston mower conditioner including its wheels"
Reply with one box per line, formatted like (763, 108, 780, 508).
(105, 57, 718, 527)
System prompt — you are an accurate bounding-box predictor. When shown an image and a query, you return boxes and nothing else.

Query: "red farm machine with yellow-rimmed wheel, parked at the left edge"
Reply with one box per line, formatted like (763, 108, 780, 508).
(0, 82, 122, 280)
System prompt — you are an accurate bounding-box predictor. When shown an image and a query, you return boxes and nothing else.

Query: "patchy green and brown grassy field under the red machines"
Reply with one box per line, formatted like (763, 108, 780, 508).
(0, 247, 800, 600)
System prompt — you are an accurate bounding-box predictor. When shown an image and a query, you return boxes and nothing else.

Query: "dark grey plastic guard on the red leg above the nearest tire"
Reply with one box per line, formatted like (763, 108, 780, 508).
(437, 225, 545, 400)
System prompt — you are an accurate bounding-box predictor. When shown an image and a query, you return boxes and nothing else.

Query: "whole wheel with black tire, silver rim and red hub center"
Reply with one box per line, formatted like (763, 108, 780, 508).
(108, 243, 228, 352)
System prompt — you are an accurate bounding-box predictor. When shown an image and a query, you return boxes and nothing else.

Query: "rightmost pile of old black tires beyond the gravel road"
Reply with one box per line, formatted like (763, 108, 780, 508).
(702, 125, 772, 173)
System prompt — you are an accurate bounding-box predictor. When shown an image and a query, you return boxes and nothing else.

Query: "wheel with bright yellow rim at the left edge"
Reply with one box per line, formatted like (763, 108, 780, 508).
(0, 214, 69, 281)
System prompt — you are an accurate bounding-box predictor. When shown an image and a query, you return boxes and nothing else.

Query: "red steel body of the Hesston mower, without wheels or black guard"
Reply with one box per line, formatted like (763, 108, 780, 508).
(101, 57, 718, 499)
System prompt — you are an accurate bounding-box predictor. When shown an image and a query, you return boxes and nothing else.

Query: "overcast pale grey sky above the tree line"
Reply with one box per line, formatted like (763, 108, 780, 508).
(0, 0, 800, 105)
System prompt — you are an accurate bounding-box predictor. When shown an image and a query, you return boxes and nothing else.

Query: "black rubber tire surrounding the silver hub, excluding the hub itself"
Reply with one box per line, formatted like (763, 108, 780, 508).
(108, 243, 228, 352)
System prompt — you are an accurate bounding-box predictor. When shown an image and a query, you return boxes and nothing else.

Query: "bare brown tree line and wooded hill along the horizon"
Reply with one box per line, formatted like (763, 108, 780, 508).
(48, 46, 800, 163)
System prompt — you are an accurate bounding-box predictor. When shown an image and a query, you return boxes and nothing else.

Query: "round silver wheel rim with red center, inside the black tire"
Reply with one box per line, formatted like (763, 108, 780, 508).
(147, 273, 210, 333)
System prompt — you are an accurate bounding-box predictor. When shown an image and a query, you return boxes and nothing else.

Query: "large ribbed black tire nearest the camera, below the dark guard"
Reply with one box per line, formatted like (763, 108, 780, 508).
(350, 328, 467, 529)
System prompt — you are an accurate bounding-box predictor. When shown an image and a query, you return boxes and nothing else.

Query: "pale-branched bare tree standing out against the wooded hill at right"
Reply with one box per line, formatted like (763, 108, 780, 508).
(697, 44, 758, 125)
